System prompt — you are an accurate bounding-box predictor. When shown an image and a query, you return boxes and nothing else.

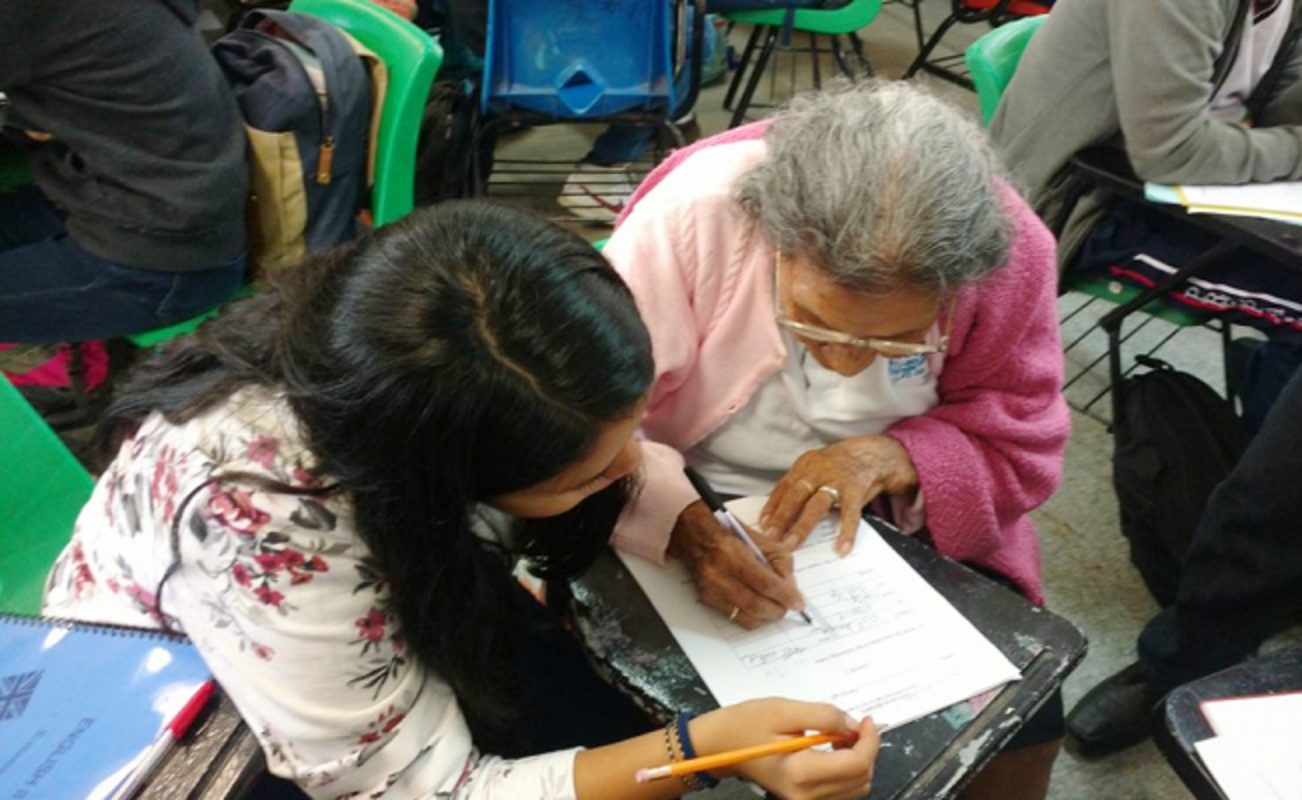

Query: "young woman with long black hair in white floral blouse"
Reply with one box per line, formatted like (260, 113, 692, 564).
(44, 202, 878, 800)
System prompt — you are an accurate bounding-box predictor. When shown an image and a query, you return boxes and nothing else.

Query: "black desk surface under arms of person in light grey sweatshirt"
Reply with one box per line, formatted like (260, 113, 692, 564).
(1072, 147, 1302, 270)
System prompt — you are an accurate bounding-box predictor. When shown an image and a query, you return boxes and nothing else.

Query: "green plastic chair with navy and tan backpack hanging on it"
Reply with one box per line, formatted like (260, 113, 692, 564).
(126, 0, 443, 348)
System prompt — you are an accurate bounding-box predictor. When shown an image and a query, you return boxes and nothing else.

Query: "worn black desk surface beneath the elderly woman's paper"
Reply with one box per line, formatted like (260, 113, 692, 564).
(573, 521, 1086, 800)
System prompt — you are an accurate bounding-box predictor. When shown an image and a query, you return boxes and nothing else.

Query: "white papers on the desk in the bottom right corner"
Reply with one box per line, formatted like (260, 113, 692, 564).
(1194, 692, 1302, 800)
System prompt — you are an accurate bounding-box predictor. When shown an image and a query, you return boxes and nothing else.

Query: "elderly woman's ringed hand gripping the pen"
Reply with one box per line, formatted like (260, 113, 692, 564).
(669, 500, 805, 629)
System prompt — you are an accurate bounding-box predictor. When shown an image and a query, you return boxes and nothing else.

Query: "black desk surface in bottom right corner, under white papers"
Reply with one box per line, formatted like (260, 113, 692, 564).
(1154, 648, 1302, 800)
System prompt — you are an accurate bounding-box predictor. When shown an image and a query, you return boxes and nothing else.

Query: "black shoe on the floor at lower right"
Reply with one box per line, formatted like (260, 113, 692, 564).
(1066, 663, 1163, 757)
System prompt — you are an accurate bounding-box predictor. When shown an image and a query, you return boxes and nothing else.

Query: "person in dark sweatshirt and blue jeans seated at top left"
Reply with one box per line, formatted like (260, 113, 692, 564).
(0, 0, 247, 343)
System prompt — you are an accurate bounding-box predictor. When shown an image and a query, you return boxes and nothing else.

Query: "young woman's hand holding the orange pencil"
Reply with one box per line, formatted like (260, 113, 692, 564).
(690, 698, 881, 800)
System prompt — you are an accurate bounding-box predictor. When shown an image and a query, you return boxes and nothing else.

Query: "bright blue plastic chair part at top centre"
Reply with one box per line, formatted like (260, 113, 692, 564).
(482, 0, 674, 120)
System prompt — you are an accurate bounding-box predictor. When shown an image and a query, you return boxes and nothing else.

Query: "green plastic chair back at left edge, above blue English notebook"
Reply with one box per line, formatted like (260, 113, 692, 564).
(0, 375, 95, 616)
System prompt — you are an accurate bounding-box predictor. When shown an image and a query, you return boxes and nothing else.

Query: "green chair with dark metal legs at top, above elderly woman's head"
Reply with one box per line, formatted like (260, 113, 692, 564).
(721, 0, 881, 128)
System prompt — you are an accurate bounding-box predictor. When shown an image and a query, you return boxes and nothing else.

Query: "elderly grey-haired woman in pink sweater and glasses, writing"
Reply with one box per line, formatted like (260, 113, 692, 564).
(604, 83, 1069, 797)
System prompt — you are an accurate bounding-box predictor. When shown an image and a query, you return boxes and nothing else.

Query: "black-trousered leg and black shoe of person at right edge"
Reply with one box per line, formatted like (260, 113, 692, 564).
(1069, 371, 1302, 754)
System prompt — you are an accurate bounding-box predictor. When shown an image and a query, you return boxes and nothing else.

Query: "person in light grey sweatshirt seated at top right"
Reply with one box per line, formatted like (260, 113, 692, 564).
(990, 0, 1302, 429)
